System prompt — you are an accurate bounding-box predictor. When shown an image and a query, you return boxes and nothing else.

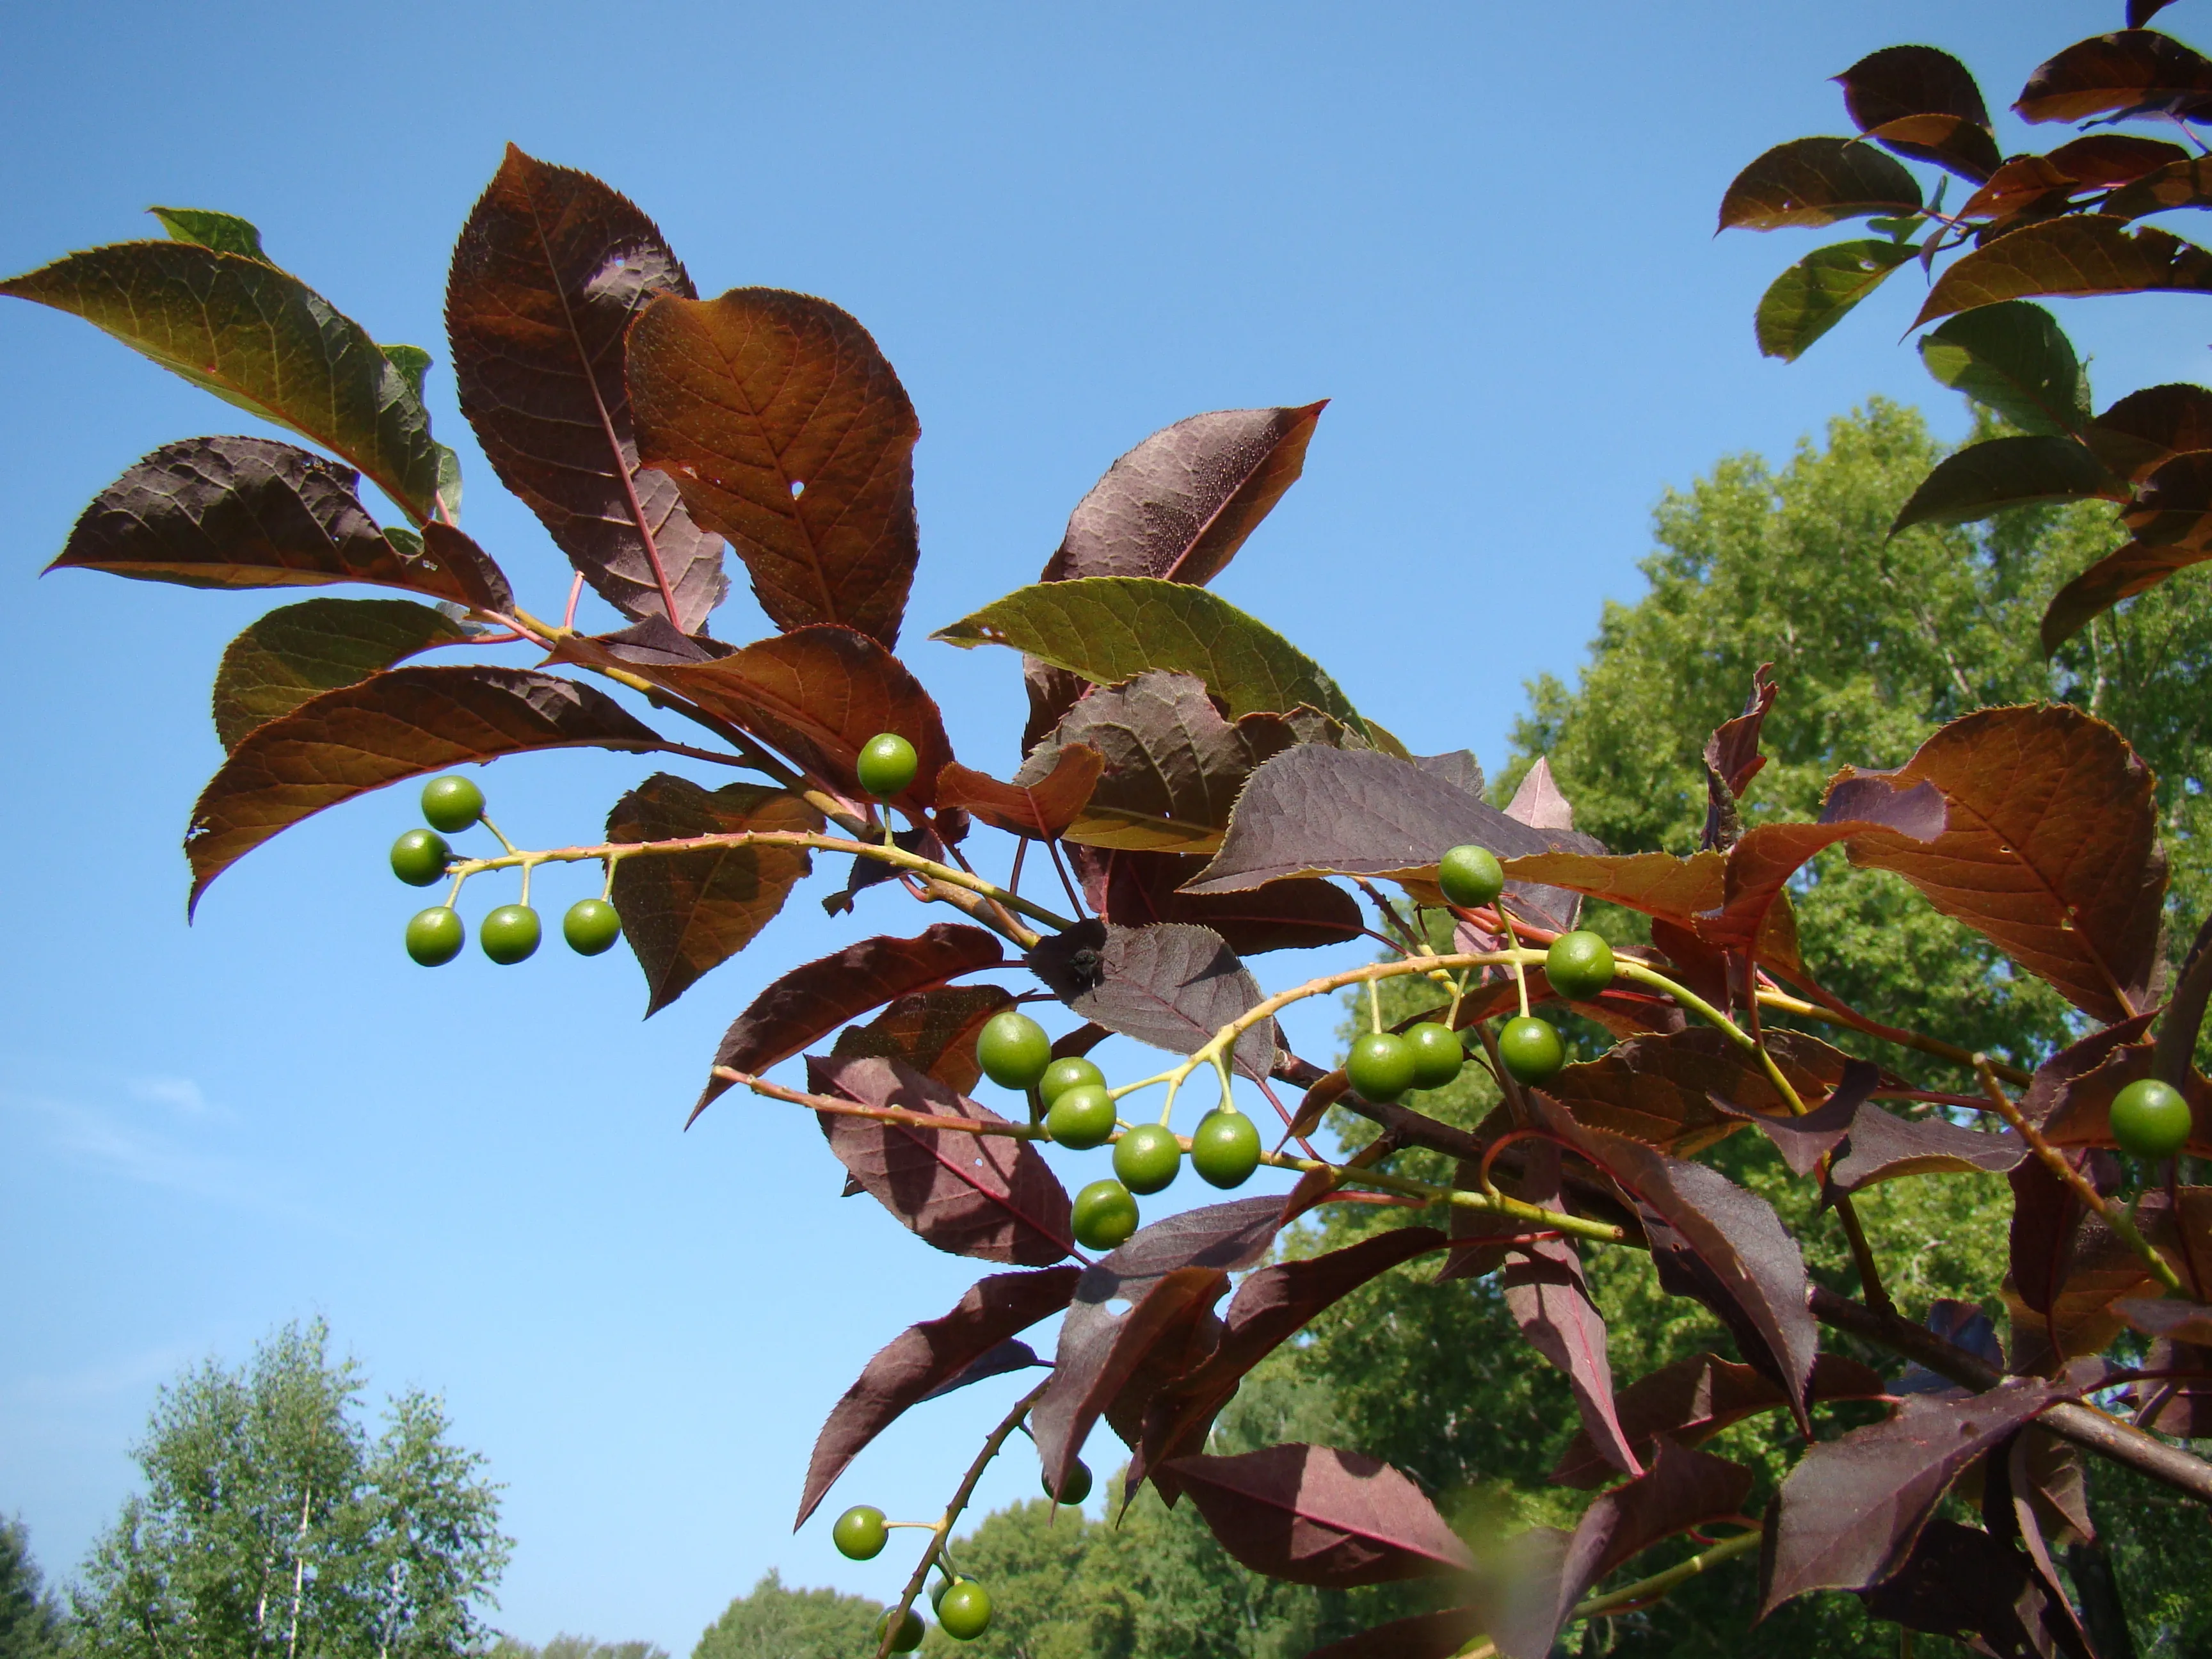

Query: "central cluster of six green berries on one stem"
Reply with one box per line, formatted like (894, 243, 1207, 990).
(975, 1009, 1261, 1250)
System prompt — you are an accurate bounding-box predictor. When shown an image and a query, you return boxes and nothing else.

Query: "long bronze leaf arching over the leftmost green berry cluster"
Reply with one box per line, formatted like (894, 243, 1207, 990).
(184, 668, 661, 907)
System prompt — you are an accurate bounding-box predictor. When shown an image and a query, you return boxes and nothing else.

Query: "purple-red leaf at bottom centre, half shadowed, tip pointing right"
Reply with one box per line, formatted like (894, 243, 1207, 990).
(1168, 1445, 1475, 1588)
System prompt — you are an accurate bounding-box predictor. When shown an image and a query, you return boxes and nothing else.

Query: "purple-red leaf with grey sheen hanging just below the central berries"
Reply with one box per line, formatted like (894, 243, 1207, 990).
(1030, 1199, 1283, 1491)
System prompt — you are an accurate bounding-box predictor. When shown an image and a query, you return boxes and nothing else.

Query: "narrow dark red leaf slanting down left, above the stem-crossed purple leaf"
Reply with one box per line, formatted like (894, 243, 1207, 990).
(693, 922, 1004, 1117)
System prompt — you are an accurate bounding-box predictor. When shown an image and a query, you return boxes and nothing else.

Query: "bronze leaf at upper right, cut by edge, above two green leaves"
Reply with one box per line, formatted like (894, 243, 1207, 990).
(1913, 214, 2212, 327)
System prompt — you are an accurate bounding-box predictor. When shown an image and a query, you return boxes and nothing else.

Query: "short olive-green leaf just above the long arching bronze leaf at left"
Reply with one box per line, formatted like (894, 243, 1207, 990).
(214, 600, 469, 750)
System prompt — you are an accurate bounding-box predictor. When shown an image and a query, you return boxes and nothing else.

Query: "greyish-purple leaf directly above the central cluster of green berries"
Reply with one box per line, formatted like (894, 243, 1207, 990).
(1029, 922, 1281, 1080)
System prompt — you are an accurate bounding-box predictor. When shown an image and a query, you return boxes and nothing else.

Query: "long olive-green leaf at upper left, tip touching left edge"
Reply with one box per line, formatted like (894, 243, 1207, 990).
(0, 241, 438, 518)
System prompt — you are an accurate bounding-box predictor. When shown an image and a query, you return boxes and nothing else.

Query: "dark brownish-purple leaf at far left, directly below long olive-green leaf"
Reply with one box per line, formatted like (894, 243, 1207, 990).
(47, 438, 469, 602)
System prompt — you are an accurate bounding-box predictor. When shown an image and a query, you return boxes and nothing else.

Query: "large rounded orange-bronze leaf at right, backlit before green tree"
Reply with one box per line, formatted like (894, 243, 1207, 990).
(1838, 703, 2165, 1022)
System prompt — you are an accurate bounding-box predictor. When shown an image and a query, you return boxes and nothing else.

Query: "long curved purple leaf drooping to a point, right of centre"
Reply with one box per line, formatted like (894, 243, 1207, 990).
(1528, 1091, 1818, 1427)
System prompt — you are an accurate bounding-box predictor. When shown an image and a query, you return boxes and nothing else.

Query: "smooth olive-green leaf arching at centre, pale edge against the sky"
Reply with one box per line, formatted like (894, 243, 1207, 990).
(933, 575, 1369, 734)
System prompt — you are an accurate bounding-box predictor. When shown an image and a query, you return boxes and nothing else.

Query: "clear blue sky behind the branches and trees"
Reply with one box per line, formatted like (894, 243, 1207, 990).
(0, 0, 2203, 1655)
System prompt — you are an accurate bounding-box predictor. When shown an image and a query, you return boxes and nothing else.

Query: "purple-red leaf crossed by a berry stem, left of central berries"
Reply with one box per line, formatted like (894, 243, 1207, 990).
(807, 1055, 1075, 1267)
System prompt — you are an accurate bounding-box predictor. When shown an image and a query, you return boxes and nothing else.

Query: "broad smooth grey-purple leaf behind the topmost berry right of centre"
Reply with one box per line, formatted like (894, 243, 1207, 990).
(1185, 743, 1599, 902)
